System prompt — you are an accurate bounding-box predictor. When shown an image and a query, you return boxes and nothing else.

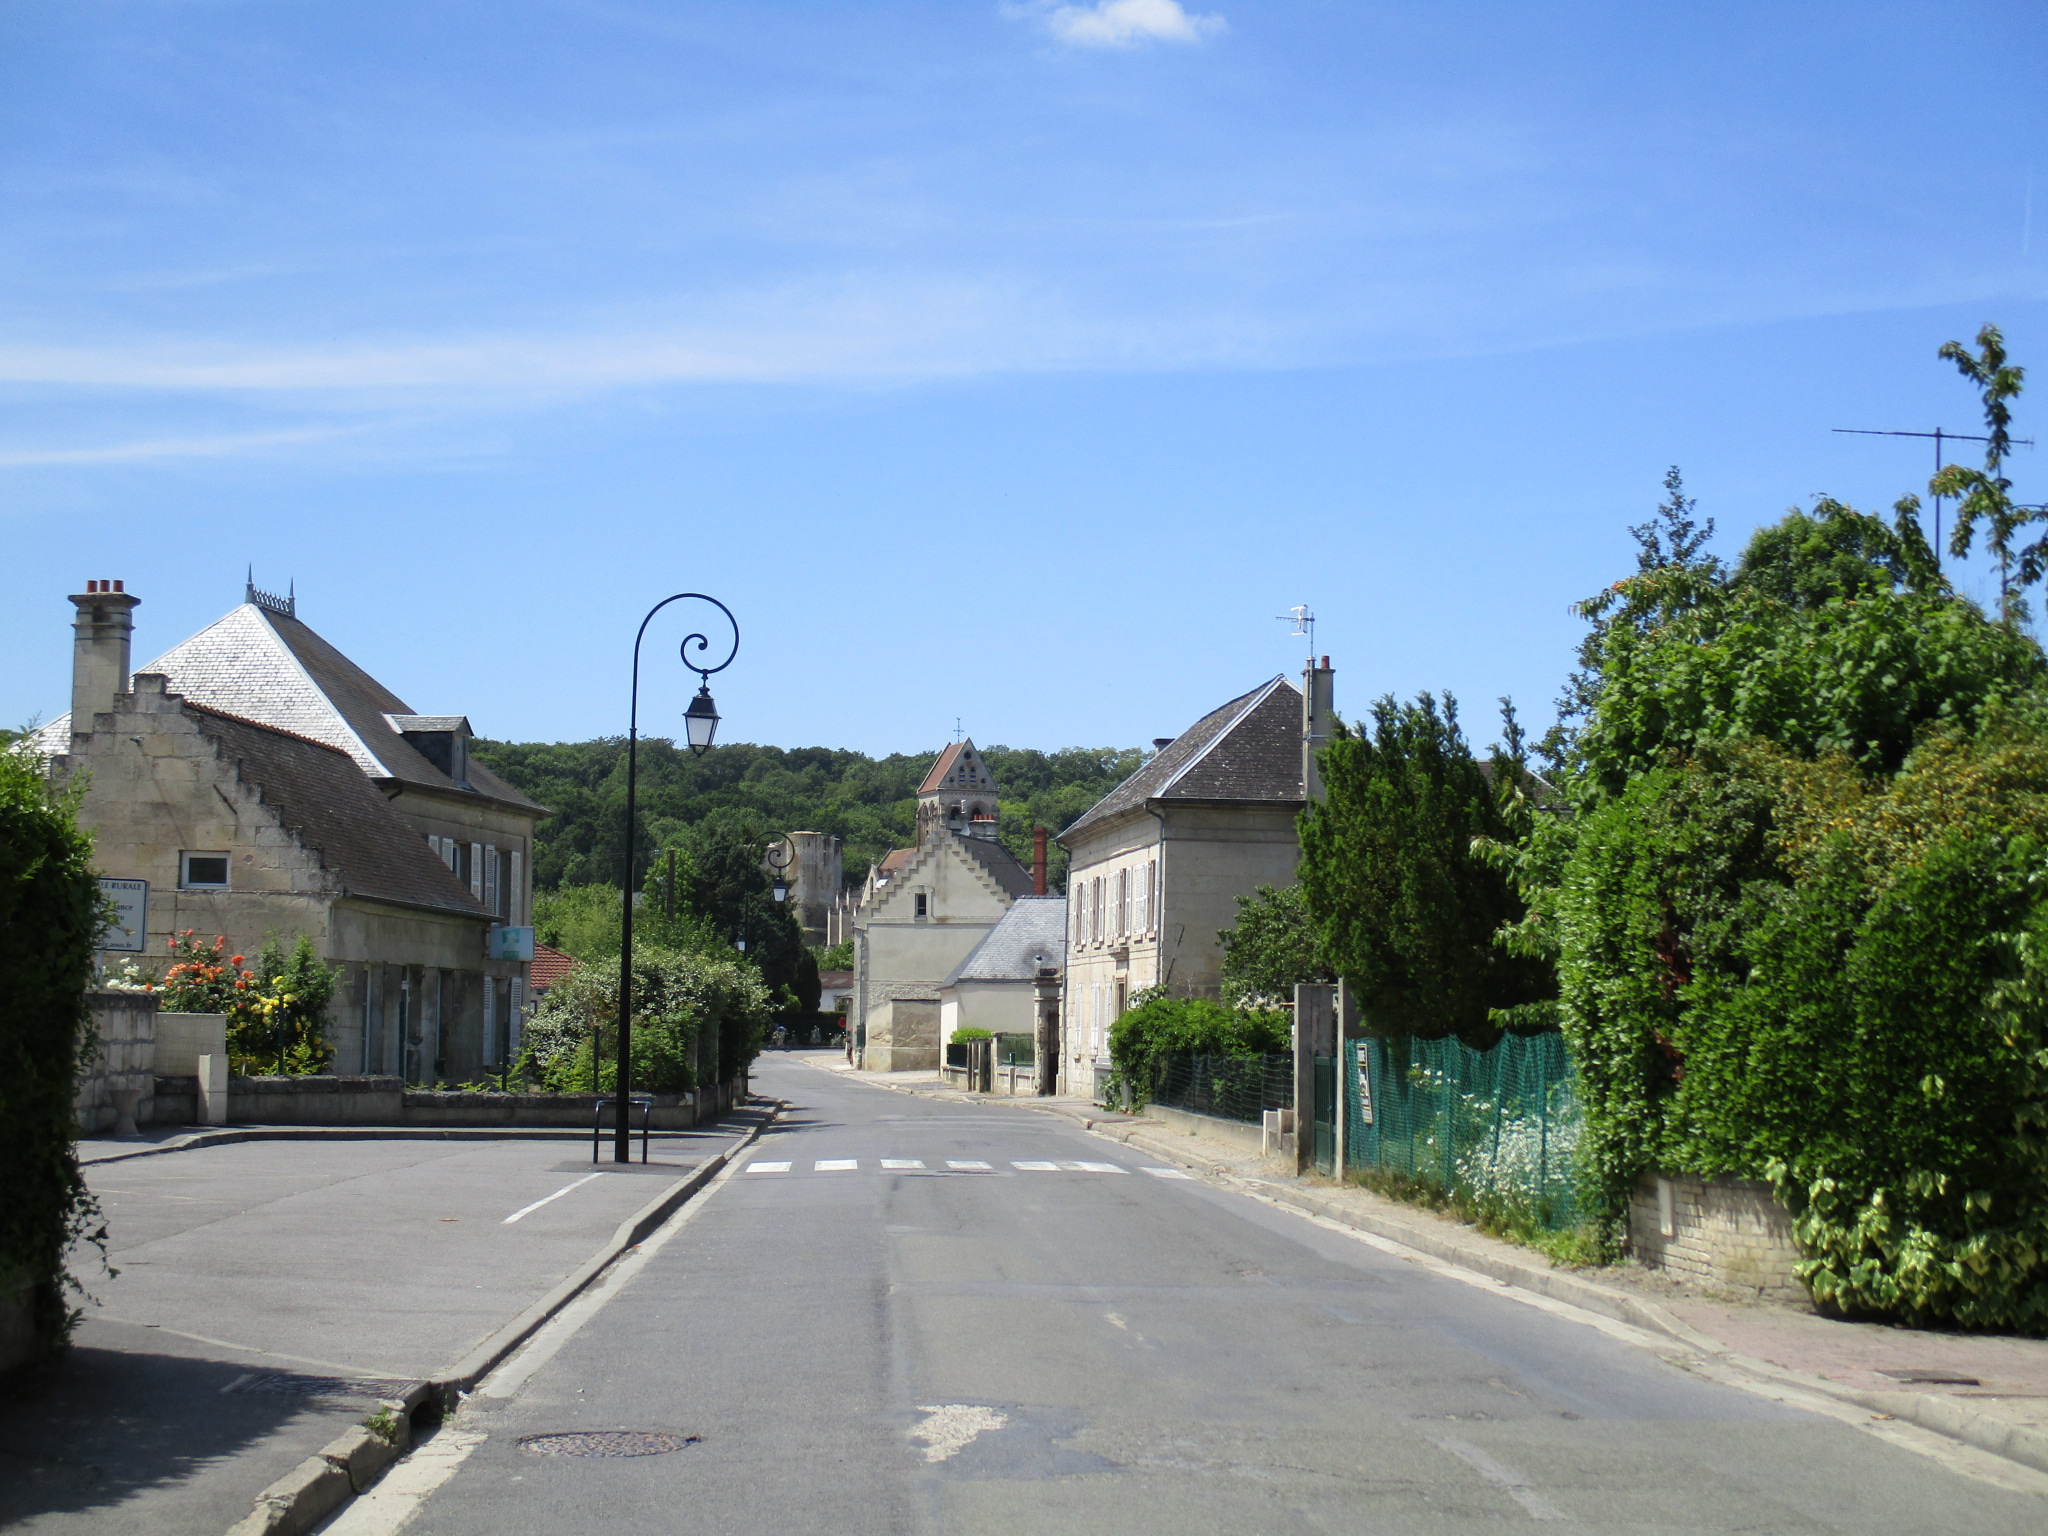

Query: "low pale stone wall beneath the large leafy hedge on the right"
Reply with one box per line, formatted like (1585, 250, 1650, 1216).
(1628, 1174, 1806, 1300)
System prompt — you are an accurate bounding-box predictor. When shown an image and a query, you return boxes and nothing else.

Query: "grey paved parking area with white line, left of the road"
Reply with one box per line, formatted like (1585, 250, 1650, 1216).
(0, 1110, 770, 1536)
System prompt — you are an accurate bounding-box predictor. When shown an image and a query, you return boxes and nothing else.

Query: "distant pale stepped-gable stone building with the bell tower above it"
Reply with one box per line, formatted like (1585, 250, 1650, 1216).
(852, 741, 1044, 1071)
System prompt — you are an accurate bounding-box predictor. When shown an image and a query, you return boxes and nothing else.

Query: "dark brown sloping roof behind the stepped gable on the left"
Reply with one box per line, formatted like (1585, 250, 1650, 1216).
(186, 700, 492, 920)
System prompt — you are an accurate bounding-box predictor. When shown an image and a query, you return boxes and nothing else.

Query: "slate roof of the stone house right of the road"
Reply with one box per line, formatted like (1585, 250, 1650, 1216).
(1059, 678, 1303, 842)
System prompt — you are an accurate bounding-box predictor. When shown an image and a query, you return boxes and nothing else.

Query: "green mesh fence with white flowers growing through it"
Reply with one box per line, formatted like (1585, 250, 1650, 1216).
(1325, 1034, 1579, 1231)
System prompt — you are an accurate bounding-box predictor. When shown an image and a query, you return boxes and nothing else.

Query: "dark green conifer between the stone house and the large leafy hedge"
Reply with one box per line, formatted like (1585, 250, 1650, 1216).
(1300, 694, 1550, 1047)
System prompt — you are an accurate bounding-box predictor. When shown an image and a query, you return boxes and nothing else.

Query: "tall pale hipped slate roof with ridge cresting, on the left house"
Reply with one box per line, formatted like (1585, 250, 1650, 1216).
(43, 602, 547, 811)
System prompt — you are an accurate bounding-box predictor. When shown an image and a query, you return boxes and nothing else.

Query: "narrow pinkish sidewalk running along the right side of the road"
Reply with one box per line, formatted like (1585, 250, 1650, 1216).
(827, 1073, 2048, 1470)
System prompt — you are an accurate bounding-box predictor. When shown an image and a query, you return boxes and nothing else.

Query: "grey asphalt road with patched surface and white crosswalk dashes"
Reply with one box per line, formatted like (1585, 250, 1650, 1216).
(372, 1061, 2048, 1536)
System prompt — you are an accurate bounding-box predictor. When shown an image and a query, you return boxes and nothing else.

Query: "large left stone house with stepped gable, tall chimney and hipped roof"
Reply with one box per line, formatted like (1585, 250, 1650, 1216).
(41, 582, 547, 1081)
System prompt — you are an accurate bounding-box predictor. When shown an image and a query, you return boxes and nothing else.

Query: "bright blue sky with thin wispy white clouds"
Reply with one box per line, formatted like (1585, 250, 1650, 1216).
(0, 0, 2048, 752)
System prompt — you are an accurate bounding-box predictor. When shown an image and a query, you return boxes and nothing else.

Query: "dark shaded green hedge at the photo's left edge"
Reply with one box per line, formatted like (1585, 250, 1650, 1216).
(0, 750, 106, 1358)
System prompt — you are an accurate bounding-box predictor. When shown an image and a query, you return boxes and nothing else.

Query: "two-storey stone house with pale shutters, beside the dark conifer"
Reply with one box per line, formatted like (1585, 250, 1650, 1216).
(1059, 657, 1333, 1092)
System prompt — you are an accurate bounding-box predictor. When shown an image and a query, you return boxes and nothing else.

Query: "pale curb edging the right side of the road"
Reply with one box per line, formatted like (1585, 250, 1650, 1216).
(1087, 1120, 2048, 1473)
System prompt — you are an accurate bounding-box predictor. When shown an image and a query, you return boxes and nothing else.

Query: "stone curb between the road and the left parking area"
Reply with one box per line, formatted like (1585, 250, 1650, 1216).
(216, 1100, 788, 1536)
